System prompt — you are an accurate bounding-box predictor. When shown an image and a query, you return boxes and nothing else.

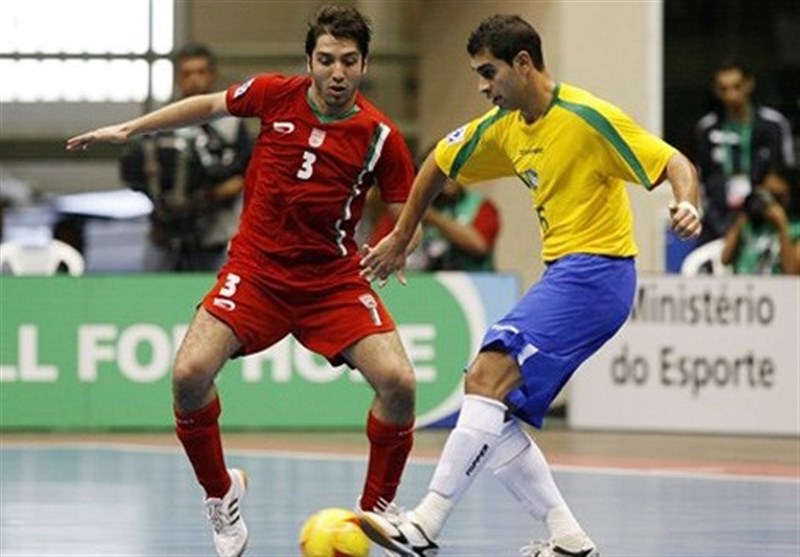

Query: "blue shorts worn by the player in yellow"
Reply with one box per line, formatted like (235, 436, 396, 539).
(481, 254, 636, 427)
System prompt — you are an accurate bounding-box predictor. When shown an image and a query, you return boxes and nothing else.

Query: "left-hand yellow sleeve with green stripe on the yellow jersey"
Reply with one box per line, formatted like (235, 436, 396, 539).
(434, 108, 515, 185)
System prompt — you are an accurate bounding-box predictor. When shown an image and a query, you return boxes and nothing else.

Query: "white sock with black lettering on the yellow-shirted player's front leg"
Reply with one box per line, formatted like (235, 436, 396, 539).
(412, 395, 506, 539)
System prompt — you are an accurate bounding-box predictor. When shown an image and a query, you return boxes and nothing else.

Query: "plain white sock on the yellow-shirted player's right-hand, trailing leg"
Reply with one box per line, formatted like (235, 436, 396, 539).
(487, 421, 583, 538)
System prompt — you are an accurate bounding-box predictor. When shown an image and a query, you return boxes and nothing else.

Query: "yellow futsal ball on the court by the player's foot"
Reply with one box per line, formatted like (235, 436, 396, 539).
(300, 508, 370, 557)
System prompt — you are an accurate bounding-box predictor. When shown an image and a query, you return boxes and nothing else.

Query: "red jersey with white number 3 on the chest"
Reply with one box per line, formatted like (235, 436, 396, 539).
(227, 74, 414, 288)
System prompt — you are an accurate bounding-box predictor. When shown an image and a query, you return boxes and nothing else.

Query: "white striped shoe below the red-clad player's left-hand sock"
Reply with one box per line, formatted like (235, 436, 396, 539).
(206, 468, 247, 557)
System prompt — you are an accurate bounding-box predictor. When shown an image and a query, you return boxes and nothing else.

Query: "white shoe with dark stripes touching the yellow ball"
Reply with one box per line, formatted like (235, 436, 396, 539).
(358, 503, 439, 557)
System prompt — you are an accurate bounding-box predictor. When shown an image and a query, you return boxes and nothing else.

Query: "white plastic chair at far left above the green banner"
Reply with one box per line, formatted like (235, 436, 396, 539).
(0, 239, 86, 277)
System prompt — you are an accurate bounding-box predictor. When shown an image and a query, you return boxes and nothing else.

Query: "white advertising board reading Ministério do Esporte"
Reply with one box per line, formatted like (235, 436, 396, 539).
(568, 276, 800, 435)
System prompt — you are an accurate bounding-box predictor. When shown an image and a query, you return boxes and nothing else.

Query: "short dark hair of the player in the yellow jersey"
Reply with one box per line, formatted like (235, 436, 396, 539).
(467, 14, 544, 71)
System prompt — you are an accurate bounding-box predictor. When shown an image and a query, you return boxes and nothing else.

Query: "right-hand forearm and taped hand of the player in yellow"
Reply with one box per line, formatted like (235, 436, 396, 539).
(659, 151, 702, 239)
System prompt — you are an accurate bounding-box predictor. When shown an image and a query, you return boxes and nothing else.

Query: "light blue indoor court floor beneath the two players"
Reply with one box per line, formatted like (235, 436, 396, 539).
(0, 434, 800, 557)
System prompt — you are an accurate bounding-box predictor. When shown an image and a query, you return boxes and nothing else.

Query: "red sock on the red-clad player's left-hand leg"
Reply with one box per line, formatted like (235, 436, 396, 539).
(175, 397, 231, 498)
